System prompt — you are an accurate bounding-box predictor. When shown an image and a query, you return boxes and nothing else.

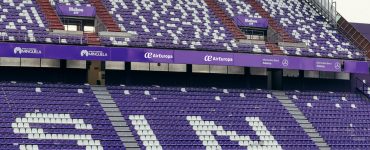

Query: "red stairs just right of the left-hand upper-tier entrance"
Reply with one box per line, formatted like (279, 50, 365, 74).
(89, 0, 121, 32)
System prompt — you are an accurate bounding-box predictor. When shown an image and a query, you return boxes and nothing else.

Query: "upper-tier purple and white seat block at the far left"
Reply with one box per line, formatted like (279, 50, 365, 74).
(0, 0, 86, 44)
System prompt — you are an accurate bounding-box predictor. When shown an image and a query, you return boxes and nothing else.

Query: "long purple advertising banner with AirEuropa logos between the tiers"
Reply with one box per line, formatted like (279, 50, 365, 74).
(0, 43, 369, 74)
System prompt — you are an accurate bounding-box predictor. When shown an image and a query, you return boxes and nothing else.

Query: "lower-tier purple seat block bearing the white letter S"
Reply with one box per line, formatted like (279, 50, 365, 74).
(0, 83, 124, 150)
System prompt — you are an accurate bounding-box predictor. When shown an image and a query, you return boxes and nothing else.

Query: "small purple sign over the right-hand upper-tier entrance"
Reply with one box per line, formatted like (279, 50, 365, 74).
(233, 15, 268, 28)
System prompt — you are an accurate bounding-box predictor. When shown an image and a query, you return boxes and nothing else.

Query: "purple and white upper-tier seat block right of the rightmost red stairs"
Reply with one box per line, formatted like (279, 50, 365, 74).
(260, 0, 364, 59)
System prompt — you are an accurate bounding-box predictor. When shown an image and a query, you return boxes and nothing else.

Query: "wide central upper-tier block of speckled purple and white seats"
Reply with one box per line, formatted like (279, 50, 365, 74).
(101, 0, 271, 53)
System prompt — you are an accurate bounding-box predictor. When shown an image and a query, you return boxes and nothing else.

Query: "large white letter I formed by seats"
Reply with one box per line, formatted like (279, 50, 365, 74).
(129, 115, 163, 150)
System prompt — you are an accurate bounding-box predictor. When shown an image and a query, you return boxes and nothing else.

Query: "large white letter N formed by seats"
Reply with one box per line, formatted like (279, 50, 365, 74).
(186, 116, 282, 150)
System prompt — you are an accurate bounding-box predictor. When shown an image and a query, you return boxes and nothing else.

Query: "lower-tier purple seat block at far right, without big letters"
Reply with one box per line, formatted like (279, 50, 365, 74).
(288, 92, 370, 150)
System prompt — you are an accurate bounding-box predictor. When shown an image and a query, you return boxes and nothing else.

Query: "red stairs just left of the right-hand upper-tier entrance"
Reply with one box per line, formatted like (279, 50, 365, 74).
(205, 0, 246, 39)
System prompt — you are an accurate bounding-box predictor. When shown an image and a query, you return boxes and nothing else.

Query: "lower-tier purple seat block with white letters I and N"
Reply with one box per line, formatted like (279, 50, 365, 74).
(108, 86, 317, 150)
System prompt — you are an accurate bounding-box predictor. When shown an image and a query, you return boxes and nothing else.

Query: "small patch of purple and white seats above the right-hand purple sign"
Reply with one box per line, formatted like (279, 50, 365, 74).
(217, 0, 261, 18)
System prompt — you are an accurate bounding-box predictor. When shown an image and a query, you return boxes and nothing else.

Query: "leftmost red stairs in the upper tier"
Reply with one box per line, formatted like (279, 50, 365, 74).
(36, 0, 64, 30)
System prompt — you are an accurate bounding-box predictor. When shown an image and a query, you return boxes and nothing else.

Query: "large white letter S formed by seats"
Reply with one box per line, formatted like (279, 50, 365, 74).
(12, 113, 103, 150)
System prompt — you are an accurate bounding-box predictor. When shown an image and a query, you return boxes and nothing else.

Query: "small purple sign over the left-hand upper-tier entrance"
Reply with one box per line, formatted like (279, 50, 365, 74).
(56, 5, 96, 17)
